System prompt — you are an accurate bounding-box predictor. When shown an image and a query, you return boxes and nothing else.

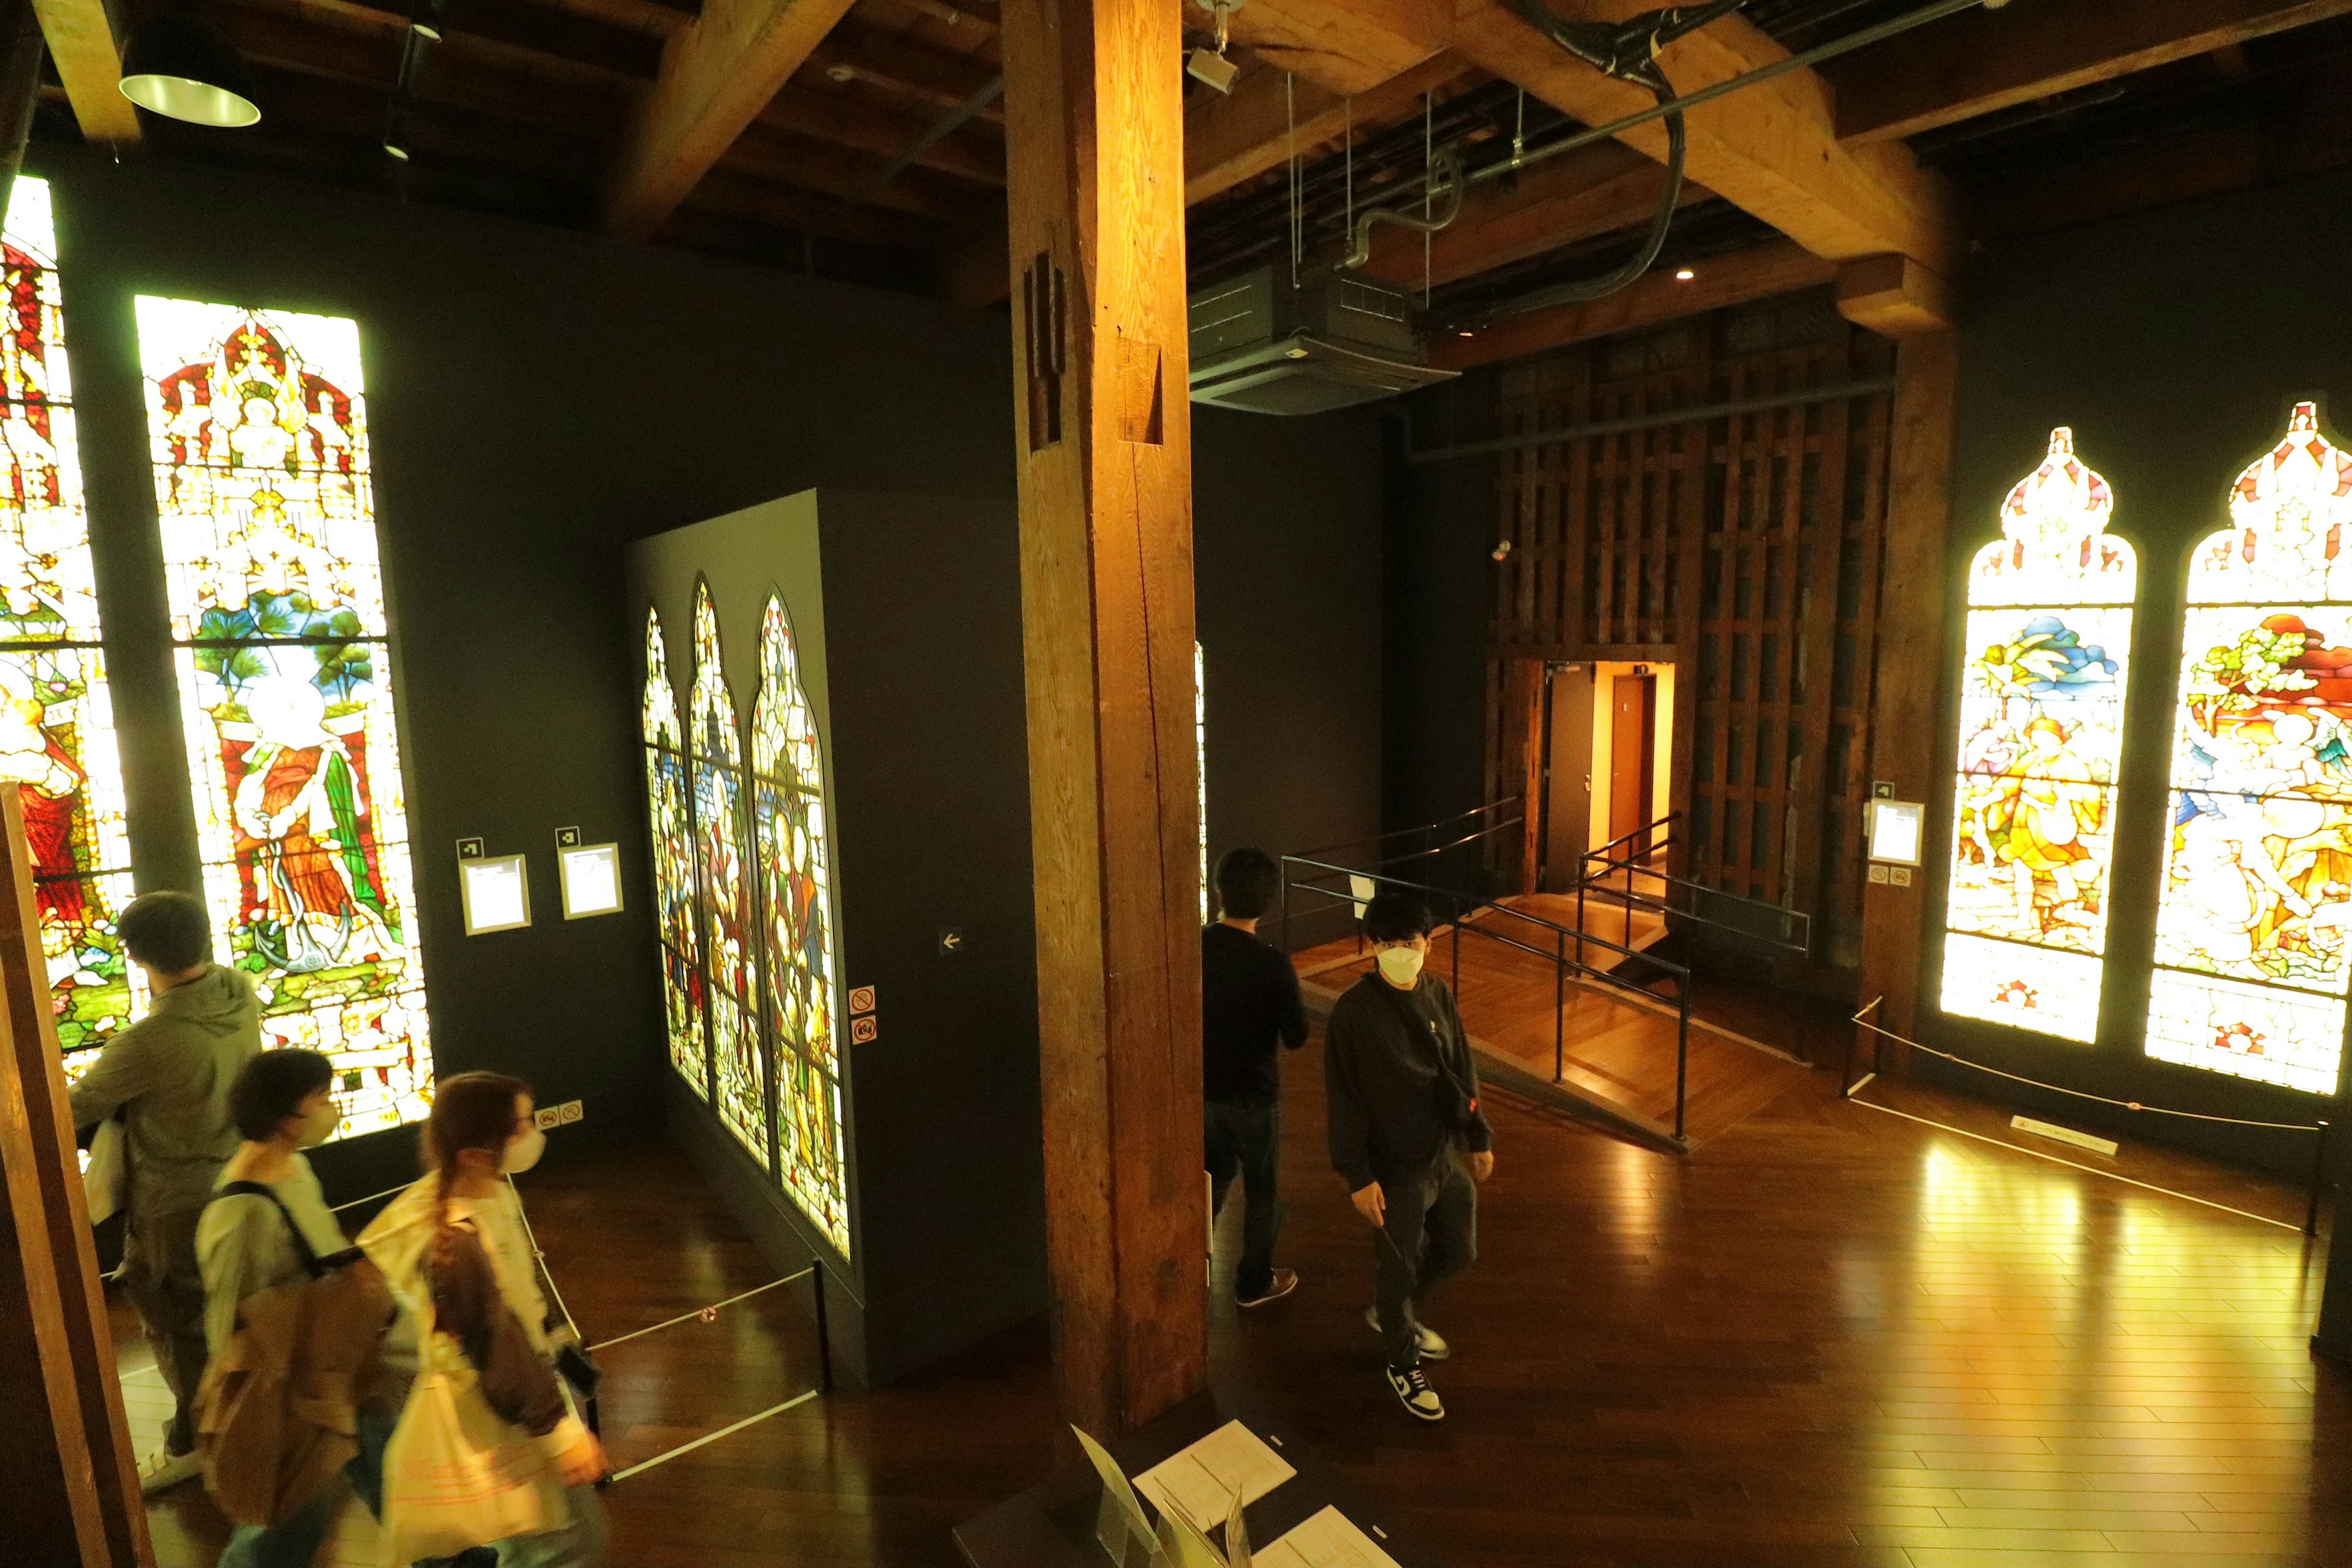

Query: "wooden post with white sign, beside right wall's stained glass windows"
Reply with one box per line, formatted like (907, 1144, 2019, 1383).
(1856, 331, 1959, 1069)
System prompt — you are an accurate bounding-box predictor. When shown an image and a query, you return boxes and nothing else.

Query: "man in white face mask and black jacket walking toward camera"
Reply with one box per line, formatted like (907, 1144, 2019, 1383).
(1324, 889, 1493, 1420)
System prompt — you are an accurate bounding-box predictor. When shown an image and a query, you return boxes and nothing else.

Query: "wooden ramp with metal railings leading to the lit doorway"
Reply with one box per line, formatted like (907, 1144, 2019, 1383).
(1296, 895, 1806, 1147)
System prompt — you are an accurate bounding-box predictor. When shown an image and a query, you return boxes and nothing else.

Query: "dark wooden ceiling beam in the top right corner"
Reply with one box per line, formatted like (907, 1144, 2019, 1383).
(1825, 0, 2352, 146)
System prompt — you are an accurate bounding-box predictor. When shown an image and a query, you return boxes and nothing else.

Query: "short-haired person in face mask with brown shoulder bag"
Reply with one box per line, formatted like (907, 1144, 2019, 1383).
(195, 1049, 390, 1568)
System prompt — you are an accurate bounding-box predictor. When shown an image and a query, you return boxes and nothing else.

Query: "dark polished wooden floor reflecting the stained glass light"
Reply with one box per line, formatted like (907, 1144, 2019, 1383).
(127, 1044, 2352, 1568)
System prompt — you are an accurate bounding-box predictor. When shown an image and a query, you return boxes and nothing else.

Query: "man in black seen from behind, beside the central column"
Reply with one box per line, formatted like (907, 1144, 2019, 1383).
(1199, 849, 1308, 1307)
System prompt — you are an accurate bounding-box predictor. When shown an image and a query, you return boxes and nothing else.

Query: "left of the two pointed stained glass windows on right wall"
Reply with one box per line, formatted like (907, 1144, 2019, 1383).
(1943, 428, 2138, 1044)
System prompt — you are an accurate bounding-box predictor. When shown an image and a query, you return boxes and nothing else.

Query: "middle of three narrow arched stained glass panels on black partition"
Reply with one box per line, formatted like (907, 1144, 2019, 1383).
(687, 583, 774, 1169)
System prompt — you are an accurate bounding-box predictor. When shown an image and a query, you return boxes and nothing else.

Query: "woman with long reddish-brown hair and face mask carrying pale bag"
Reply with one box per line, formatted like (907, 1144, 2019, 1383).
(360, 1072, 607, 1568)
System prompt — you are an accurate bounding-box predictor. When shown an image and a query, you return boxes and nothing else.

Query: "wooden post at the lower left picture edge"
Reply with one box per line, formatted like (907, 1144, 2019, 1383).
(0, 783, 155, 1568)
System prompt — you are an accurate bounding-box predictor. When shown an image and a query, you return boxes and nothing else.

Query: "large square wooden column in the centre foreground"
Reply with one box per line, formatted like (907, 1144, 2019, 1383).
(1002, 0, 1204, 1436)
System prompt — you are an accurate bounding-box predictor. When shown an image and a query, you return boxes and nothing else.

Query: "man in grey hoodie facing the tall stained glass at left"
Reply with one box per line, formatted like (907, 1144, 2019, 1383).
(73, 893, 261, 1493)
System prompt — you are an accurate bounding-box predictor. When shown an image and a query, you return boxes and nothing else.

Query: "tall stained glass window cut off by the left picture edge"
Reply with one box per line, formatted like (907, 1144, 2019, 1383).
(0, 174, 141, 1072)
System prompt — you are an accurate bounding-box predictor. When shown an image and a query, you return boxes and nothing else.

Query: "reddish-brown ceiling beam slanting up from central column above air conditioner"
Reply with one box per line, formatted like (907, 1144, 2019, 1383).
(1183, 54, 1487, 205)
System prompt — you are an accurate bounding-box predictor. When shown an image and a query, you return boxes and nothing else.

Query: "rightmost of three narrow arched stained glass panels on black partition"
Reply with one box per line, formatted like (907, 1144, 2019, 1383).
(750, 595, 849, 1256)
